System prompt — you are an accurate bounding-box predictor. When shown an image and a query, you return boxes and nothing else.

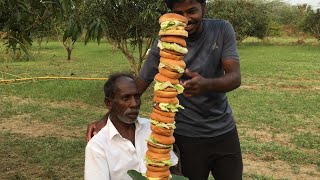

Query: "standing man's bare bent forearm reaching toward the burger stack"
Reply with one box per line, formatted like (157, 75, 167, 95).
(182, 59, 241, 97)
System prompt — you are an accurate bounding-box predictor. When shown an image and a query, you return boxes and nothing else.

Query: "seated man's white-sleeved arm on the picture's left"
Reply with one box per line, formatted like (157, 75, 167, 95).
(84, 142, 110, 180)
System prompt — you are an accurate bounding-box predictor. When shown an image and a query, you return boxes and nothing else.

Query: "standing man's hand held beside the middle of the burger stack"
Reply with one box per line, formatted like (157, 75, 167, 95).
(182, 69, 206, 97)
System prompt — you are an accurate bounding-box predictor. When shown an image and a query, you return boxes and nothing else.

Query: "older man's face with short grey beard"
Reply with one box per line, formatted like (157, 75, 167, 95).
(110, 77, 141, 124)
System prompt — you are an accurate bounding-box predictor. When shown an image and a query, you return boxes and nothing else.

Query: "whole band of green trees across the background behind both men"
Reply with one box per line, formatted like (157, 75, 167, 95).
(0, 0, 320, 71)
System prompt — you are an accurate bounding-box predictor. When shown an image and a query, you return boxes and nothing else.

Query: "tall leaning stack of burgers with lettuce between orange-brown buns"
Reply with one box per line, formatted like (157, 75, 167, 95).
(145, 13, 188, 179)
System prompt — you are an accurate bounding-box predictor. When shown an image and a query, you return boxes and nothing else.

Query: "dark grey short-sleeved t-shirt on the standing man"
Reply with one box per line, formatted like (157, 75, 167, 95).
(139, 19, 239, 137)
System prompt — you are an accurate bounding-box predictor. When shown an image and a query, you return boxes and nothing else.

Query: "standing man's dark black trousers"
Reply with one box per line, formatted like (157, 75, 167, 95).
(174, 128, 243, 180)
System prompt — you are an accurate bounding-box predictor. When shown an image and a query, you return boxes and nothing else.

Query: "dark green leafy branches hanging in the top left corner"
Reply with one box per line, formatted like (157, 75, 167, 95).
(0, 0, 78, 60)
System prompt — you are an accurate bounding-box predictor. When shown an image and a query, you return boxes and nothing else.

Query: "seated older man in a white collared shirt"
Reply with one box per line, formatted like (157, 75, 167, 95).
(85, 74, 178, 180)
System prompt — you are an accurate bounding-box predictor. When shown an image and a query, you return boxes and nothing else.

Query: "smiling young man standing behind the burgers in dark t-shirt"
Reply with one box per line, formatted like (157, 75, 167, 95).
(87, 0, 243, 180)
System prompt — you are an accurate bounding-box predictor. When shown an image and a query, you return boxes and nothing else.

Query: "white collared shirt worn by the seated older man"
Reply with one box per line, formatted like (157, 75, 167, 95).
(84, 117, 178, 180)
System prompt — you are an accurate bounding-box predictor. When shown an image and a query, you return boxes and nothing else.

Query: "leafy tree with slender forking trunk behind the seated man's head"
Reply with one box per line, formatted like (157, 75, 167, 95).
(85, 0, 166, 75)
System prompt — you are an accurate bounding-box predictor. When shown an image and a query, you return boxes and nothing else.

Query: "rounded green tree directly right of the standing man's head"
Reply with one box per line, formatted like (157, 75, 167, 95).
(207, 0, 270, 42)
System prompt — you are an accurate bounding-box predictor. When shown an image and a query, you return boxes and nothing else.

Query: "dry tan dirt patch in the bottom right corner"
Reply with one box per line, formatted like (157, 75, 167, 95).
(243, 154, 320, 180)
